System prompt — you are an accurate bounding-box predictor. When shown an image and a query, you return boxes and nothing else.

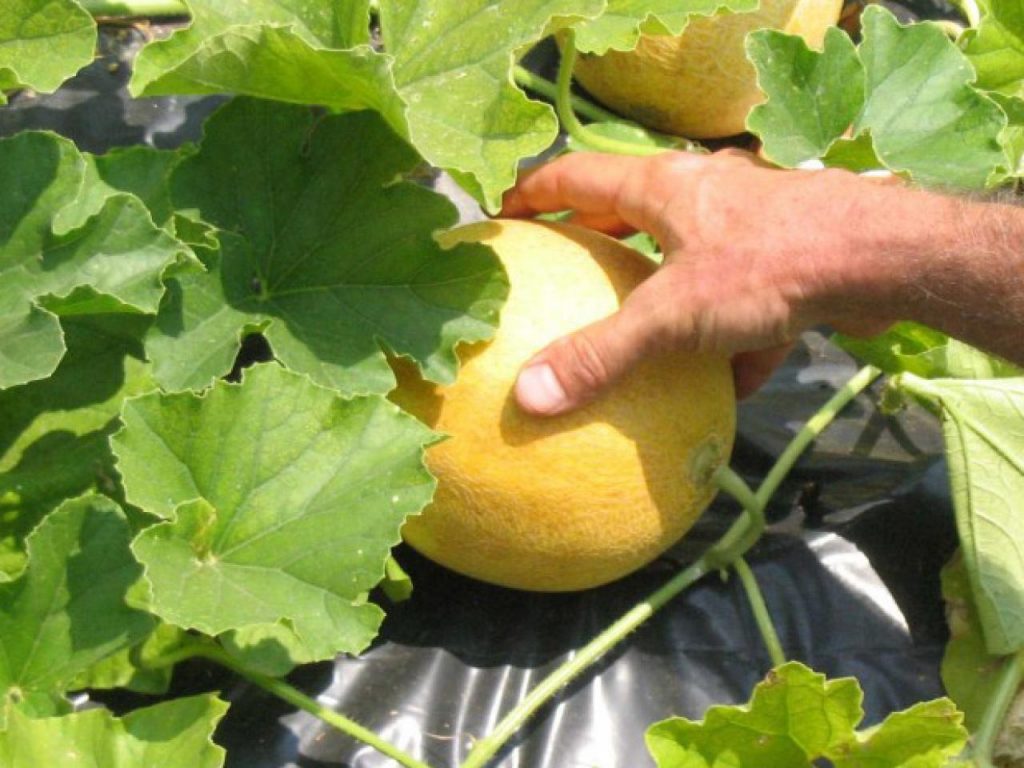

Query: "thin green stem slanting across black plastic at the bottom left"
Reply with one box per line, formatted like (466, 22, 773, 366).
(145, 639, 430, 768)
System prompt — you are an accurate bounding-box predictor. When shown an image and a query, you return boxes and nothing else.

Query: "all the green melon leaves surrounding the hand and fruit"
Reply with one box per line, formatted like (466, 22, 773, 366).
(0, 0, 1024, 768)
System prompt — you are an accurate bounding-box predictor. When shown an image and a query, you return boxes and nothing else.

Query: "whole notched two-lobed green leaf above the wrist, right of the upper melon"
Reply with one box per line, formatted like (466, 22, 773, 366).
(748, 6, 1015, 188)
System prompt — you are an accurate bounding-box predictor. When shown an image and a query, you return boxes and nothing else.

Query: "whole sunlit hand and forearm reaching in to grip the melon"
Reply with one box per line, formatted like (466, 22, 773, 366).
(503, 150, 1024, 415)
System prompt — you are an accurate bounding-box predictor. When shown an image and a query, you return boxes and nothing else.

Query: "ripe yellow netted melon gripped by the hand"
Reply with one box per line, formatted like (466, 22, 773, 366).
(392, 221, 735, 591)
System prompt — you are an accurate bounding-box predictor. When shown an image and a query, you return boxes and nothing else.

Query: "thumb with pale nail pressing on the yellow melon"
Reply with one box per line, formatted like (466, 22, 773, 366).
(515, 289, 659, 416)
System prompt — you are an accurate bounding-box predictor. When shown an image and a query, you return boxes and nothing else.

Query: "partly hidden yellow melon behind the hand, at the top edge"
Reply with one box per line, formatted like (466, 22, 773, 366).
(572, 0, 843, 138)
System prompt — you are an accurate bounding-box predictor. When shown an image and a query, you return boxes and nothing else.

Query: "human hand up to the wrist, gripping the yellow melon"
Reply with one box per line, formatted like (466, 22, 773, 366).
(503, 151, 913, 415)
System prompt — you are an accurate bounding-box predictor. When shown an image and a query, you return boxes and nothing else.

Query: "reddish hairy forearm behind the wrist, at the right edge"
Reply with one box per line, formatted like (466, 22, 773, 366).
(823, 186, 1024, 365)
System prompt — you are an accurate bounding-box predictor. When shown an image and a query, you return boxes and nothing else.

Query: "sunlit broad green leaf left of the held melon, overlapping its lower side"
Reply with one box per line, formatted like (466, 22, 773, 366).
(113, 364, 434, 660)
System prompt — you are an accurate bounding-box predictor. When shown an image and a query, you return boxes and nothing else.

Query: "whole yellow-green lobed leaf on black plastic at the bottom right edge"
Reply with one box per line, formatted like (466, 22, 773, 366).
(646, 662, 968, 768)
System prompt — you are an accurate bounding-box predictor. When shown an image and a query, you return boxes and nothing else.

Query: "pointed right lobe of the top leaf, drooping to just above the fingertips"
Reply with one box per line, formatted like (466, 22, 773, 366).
(380, 0, 606, 212)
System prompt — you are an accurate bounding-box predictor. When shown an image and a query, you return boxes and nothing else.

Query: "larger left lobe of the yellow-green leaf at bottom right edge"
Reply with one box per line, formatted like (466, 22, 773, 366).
(646, 662, 863, 768)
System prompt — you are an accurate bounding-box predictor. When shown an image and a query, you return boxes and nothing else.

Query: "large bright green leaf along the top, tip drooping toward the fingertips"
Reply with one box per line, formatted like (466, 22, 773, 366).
(132, 0, 606, 210)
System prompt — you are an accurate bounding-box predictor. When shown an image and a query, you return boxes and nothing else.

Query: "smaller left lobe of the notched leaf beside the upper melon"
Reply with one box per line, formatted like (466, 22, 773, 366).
(746, 27, 864, 167)
